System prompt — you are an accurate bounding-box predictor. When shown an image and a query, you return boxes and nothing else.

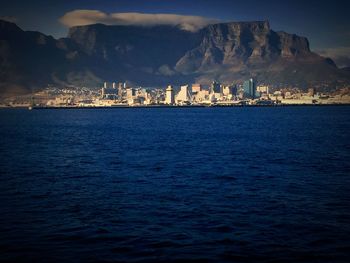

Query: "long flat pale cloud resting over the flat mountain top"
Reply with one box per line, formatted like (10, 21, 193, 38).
(59, 10, 219, 31)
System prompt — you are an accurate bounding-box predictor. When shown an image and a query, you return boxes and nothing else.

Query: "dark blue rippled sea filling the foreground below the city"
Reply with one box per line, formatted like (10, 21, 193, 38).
(0, 107, 350, 262)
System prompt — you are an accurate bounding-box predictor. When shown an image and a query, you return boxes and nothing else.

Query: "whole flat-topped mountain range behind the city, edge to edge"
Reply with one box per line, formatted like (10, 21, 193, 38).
(0, 21, 350, 94)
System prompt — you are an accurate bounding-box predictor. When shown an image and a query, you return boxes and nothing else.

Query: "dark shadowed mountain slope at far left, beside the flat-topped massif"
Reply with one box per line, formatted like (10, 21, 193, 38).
(0, 20, 101, 95)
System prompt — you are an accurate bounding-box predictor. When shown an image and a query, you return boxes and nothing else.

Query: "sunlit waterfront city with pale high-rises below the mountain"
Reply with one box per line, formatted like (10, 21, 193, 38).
(0, 79, 350, 109)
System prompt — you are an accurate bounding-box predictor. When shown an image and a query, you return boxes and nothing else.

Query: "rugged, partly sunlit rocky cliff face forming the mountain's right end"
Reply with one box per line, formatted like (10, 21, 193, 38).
(176, 22, 349, 86)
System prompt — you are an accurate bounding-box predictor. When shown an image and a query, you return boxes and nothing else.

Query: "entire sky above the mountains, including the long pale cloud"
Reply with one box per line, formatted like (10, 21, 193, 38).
(0, 0, 350, 66)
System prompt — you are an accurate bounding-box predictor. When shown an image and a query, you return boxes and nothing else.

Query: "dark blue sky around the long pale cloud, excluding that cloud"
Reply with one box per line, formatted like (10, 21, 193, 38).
(0, 0, 350, 65)
